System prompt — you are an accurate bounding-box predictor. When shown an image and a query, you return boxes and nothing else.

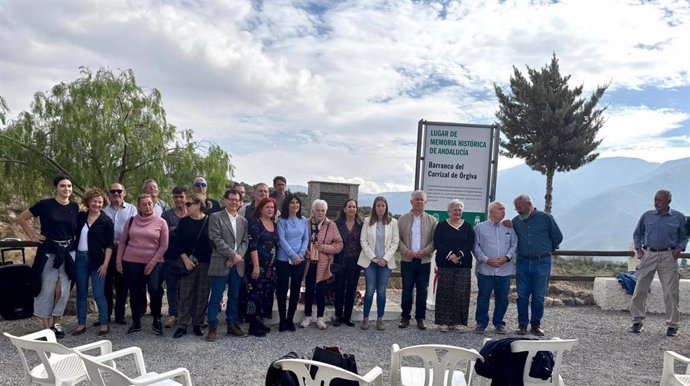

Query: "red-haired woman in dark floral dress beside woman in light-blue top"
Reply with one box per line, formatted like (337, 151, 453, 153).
(247, 197, 279, 337)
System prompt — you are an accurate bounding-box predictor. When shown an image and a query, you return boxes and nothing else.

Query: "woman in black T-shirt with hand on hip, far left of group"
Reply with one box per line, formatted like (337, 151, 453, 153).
(17, 176, 79, 338)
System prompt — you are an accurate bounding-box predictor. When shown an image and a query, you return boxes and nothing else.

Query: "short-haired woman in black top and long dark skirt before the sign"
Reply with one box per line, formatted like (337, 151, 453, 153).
(434, 200, 474, 332)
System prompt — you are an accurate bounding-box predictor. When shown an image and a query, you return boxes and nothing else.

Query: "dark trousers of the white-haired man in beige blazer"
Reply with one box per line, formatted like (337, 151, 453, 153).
(400, 259, 431, 319)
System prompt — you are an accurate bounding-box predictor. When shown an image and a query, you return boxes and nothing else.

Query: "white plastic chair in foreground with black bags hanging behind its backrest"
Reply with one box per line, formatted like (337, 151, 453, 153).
(273, 359, 383, 386)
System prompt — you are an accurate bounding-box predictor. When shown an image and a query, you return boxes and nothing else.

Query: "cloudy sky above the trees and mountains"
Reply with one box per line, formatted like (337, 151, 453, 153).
(0, 0, 690, 192)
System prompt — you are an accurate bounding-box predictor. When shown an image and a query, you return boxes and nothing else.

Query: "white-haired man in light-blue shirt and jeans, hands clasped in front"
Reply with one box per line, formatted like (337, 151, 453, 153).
(474, 201, 517, 334)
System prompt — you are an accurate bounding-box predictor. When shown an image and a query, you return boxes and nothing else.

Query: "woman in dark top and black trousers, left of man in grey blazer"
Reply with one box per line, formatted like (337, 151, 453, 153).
(173, 193, 211, 338)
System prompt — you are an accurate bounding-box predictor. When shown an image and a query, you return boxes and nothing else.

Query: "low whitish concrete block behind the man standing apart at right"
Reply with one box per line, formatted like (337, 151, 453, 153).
(593, 277, 690, 314)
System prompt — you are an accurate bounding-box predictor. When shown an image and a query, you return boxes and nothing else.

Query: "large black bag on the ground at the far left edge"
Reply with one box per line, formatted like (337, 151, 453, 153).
(0, 250, 34, 320)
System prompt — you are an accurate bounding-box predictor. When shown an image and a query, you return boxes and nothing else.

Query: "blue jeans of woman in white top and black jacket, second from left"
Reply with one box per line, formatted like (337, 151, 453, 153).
(75, 251, 108, 326)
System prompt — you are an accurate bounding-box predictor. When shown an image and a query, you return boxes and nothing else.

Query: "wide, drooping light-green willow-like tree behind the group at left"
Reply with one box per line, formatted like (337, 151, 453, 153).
(0, 68, 232, 201)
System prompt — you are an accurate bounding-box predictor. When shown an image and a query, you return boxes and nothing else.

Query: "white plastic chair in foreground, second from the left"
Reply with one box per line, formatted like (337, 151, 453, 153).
(77, 346, 192, 386)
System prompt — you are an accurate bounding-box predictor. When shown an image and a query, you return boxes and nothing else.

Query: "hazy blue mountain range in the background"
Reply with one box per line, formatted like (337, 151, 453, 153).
(290, 157, 690, 251)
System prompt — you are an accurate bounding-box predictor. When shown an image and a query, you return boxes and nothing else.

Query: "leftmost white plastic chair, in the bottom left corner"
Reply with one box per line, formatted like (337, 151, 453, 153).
(3, 329, 113, 386)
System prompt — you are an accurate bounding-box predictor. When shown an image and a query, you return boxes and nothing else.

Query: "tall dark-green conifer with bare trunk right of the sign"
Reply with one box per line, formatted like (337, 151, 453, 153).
(494, 54, 608, 213)
